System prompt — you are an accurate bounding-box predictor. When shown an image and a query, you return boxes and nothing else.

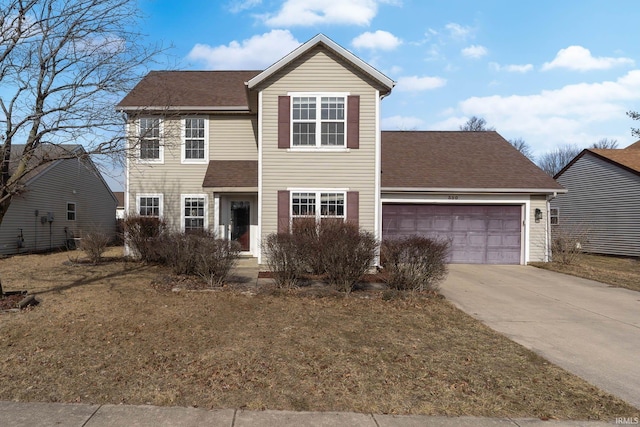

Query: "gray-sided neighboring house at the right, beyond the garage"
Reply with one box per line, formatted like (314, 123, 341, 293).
(551, 141, 640, 257)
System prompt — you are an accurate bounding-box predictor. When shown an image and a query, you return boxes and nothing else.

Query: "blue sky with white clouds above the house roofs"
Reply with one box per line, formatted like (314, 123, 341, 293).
(127, 0, 640, 172)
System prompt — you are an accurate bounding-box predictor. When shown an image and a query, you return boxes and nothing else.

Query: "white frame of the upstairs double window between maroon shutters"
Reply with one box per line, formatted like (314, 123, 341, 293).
(287, 92, 350, 151)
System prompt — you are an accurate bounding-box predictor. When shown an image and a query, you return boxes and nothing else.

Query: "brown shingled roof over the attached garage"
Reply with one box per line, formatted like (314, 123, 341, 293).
(382, 131, 564, 192)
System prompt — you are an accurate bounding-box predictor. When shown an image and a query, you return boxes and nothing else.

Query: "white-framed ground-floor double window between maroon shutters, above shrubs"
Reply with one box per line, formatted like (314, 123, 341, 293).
(291, 191, 345, 221)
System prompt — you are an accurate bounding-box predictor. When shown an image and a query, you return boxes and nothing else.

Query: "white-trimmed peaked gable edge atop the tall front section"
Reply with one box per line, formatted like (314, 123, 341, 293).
(247, 34, 395, 94)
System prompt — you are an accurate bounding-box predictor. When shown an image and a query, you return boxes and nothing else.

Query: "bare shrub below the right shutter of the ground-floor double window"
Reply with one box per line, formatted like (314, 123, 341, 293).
(316, 220, 378, 296)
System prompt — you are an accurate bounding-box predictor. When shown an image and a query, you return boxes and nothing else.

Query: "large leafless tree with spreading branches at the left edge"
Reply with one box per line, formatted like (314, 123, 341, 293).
(0, 0, 160, 292)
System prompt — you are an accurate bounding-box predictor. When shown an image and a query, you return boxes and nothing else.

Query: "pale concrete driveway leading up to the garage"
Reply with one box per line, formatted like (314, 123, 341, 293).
(441, 264, 640, 408)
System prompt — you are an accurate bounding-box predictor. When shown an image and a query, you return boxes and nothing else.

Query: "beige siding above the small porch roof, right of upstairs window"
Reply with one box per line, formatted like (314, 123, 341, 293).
(209, 116, 258, 160)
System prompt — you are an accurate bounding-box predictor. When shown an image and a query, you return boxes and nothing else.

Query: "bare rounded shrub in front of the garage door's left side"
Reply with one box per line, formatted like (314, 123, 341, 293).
(380, 235, 451, 291)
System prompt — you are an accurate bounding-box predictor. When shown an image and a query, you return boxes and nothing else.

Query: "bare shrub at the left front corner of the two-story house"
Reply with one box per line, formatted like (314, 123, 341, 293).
(124, 215, 167, 262)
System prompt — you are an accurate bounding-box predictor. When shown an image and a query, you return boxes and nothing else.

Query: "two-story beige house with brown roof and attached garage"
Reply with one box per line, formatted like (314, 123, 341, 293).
(118, 34, 561, 263)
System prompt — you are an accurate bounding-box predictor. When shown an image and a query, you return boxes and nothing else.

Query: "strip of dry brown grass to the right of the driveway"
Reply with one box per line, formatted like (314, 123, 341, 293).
(532, 254, 640, 291)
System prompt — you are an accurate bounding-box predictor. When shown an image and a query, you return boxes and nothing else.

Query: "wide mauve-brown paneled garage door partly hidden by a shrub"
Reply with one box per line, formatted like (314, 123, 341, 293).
(382, 204, 522, 264)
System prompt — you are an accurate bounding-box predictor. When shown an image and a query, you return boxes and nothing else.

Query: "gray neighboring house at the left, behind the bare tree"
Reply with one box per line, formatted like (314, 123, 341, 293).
(0, 145, 116, 254)
